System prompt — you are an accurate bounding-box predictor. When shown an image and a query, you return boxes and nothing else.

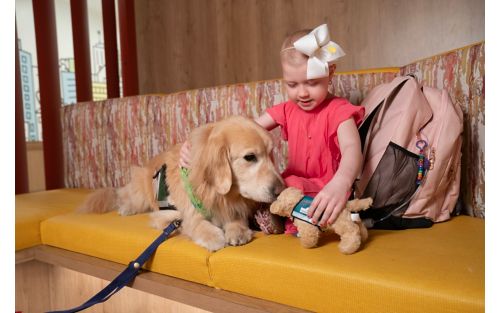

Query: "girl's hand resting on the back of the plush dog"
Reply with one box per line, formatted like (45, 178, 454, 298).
(307, 180, 350, 227)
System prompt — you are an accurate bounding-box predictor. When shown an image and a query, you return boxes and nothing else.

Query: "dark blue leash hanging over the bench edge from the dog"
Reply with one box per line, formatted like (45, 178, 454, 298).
(47, 220, 181, 313)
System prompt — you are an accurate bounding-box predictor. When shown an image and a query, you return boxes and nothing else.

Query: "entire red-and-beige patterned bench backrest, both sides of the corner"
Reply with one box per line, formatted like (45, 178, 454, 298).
(62, 43, 485, 217)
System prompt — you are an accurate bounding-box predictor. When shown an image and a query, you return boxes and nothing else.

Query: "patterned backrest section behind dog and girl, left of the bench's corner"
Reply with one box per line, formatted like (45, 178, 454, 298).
(62, 69, 398, 188)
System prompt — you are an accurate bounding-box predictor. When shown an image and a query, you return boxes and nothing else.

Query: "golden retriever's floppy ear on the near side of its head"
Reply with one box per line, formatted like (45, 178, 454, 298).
(191, 125, 233, 195)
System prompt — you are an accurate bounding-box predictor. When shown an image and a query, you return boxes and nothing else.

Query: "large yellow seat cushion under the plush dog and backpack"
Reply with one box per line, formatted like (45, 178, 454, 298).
(210, 216, 484, 312)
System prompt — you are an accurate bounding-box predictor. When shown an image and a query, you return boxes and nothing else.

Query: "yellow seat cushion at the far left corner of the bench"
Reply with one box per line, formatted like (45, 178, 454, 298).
(16, 189, 90, 251)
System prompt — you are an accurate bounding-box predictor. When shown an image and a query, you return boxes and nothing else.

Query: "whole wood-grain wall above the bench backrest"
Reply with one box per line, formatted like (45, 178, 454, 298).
(135, 0, 484, 93)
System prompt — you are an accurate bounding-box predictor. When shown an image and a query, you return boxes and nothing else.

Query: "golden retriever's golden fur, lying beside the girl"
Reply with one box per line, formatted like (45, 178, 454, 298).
(80, 116, 284, 251)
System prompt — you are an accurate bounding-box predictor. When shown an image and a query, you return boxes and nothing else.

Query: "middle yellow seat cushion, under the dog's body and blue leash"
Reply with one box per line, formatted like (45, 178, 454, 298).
(41, 212, 212, 286)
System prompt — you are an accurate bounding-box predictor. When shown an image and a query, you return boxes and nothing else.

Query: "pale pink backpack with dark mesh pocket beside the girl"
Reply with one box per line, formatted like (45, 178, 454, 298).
(356, 76, 463, 229)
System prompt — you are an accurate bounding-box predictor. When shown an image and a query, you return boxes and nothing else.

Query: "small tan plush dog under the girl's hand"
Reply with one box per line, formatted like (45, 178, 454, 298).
(270, 187, 373, 254)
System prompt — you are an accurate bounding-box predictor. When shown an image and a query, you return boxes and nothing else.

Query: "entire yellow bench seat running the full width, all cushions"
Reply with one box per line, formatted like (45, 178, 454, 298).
(16, 189, 484, 312)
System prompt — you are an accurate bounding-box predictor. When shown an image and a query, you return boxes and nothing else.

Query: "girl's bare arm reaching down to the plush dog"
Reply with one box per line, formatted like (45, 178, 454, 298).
(308, 118, 363, 226)
